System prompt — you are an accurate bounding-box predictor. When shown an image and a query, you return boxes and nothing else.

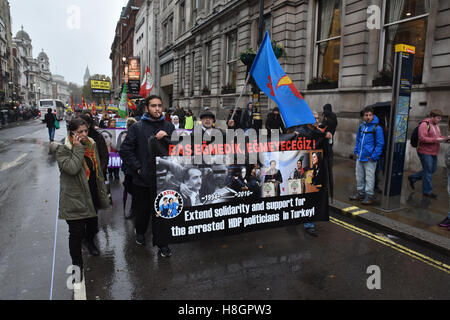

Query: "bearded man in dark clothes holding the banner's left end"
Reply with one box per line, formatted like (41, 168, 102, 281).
(120, 95, 175, 257)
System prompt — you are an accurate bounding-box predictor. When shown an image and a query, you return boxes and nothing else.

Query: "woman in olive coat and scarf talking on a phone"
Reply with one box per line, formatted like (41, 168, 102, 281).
(56, 118, 109, 282)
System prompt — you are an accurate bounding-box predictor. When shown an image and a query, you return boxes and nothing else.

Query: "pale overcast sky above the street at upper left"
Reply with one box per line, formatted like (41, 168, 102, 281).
(9, 0, 128, 85)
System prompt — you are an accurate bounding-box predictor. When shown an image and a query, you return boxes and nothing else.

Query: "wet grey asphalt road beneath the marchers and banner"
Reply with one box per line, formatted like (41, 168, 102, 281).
(0, 121, 450, 300)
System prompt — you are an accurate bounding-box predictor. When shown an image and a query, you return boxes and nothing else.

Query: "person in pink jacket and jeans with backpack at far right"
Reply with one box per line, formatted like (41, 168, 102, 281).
(408, 109, 450, 199)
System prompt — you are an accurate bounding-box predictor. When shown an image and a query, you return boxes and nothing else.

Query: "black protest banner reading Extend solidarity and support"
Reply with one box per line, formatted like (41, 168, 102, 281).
(152, 132, 329, 244)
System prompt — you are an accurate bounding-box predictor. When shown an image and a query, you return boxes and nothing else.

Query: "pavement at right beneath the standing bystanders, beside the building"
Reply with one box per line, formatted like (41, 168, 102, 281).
(331, 157, 450, 251)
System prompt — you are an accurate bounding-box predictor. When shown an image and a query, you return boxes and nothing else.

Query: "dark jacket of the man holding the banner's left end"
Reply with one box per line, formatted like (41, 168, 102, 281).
(119, 114, 175, 187)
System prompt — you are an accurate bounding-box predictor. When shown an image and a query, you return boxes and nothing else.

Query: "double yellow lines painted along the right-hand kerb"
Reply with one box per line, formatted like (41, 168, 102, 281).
(330, 217, 450, 274)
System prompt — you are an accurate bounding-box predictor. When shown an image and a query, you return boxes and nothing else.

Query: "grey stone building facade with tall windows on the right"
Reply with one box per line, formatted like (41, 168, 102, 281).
(164, 0, 450, 169)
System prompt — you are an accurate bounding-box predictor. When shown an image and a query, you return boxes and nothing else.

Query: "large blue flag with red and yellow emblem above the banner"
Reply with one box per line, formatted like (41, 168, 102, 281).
(250, 31, 316, 128)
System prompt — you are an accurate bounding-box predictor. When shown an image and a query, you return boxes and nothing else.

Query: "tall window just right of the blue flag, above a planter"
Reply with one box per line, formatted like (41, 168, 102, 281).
(315, 0, 341, 81)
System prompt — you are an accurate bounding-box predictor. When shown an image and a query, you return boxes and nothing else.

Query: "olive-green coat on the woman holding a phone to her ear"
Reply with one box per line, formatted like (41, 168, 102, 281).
(56, 138, 110, 220)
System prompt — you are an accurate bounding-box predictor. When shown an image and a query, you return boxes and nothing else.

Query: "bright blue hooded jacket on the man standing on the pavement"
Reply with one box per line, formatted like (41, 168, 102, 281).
(353, 115, 384, 162)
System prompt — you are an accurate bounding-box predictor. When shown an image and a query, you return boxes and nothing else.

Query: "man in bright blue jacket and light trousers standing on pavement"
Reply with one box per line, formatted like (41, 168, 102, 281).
(350, 107, 384, 204)
